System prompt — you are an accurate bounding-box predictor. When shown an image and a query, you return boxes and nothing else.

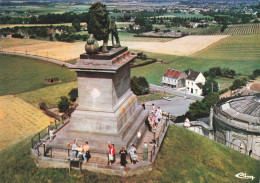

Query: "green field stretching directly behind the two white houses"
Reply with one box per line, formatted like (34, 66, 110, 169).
(131, 52, 260, 89)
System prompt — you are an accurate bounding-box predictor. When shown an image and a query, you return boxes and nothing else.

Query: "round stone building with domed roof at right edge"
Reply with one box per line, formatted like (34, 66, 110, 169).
(213, 94, 260, 159)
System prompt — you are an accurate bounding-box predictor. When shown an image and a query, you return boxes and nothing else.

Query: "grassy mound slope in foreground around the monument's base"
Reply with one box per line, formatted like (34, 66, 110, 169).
(0, 126, 260, 183)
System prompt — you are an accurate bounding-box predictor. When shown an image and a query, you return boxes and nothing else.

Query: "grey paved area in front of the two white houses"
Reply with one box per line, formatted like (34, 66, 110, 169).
(145, 96, 195, 116)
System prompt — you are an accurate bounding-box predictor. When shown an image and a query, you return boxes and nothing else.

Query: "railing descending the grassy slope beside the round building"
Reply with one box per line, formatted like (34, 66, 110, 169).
(181, 125, 260, 160)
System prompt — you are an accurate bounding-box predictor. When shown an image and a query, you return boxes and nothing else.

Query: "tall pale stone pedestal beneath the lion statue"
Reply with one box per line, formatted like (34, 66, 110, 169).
(48, 47, 148, 152)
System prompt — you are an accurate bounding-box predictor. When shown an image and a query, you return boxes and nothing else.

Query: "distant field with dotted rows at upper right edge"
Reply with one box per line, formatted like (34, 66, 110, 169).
(212, 23, 260, 36)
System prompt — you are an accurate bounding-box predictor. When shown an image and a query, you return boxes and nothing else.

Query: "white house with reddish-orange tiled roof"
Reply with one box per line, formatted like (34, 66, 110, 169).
(162, 69, 187, 88)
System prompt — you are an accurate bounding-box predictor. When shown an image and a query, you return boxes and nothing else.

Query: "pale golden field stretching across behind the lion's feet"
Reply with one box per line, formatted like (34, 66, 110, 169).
(0, 34, 226, 61)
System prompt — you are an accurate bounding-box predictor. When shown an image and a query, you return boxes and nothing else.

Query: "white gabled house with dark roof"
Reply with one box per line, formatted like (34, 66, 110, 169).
(185, 70, 206, 95)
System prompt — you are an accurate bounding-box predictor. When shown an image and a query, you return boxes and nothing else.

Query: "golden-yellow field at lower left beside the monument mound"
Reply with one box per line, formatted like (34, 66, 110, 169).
(0, 95, 53, 150)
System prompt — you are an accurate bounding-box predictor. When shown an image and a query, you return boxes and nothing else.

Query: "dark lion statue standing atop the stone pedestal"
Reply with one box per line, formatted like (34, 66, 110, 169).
(87, 2, 121, 53)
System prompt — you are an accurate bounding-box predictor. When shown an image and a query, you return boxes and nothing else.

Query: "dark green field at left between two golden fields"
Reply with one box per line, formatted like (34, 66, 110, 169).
(0, 55, 76, 95)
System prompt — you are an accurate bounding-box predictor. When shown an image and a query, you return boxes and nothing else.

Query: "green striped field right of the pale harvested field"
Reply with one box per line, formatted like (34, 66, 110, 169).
(194, 34, 260, 60)
